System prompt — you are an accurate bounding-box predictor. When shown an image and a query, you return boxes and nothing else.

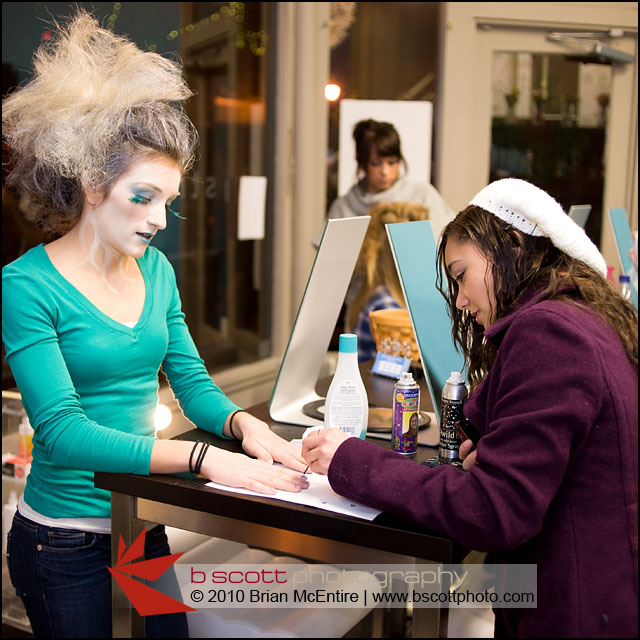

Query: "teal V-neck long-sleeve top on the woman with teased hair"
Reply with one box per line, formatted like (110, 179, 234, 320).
(2, 245, 238, 518)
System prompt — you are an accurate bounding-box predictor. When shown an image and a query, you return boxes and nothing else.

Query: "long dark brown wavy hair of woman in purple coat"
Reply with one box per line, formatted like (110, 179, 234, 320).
(437, 205, 638, 389)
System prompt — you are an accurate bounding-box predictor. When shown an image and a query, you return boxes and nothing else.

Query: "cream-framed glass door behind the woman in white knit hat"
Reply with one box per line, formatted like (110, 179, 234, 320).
(436, 3, 638, 270)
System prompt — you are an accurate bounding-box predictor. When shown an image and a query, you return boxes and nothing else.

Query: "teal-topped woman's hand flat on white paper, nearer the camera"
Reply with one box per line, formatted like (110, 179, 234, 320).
(200, 446, 309, 495)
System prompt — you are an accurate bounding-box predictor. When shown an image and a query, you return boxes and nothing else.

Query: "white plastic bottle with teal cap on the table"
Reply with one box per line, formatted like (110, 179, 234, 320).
(324, 333, 369, 440)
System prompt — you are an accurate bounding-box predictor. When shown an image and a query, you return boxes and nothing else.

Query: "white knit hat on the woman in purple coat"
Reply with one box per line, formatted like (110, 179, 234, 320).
(469, 178, 607, 276)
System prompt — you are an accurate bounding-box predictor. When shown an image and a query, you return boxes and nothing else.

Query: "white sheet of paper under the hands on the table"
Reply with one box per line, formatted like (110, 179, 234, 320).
(205, 432, 382, 520)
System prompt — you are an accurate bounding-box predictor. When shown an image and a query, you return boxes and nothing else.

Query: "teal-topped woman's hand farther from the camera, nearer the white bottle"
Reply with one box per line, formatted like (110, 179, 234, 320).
(233, 411, 307, 471)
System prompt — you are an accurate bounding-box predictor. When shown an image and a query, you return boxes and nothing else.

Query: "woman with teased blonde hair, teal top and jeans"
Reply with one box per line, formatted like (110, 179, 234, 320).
(2, 11, 307, 637)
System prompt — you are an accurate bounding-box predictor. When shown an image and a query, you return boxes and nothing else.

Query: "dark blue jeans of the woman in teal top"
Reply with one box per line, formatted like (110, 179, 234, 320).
(7, 512, 189, 638)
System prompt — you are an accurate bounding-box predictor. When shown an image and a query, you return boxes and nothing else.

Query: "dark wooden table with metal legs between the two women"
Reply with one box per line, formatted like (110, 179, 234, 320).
(95, 364, 465, 638)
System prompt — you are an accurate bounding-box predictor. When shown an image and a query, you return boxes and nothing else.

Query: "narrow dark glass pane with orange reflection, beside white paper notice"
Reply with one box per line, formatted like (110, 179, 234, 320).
(179, 2, 272, 370)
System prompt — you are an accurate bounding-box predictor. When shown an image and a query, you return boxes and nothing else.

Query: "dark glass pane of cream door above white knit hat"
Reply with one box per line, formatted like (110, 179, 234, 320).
(489, 52, 611, 246)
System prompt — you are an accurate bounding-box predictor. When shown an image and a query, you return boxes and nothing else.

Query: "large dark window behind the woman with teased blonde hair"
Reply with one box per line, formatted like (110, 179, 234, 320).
(2, 2, 275, 388)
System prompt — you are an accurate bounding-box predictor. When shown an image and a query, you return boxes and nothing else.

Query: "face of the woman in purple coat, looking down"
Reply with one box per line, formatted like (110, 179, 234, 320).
(445, 238, 496, 329)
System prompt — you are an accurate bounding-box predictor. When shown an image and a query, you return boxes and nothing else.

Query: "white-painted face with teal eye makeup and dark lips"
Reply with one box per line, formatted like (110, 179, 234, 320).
(86, 158, 182, 258)
